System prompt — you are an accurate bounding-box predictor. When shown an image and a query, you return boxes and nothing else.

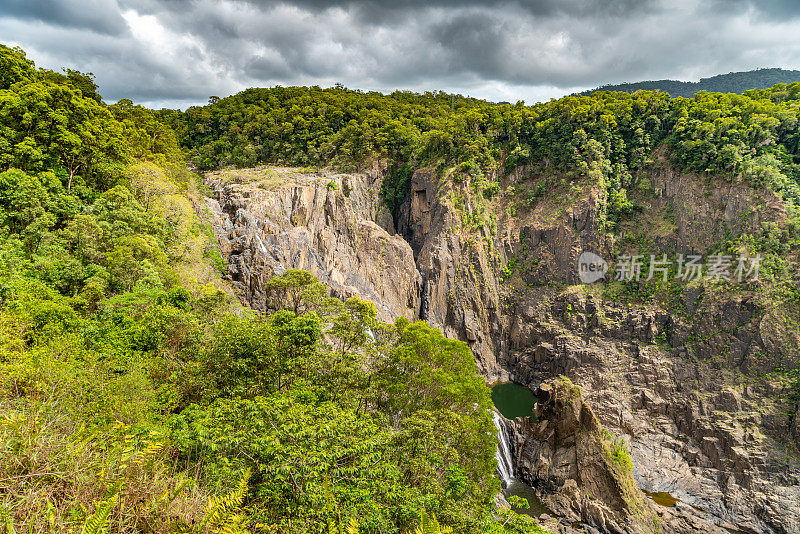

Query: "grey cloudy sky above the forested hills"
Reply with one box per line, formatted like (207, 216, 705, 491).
(0, 0, 800, 108)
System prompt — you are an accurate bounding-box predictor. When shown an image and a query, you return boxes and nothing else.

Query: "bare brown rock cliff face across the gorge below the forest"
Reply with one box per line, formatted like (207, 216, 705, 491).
(202, 158, 800, 533)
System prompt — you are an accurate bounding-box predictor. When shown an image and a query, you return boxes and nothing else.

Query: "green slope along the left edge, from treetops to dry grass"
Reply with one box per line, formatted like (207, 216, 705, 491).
(0, 47, 241, 532)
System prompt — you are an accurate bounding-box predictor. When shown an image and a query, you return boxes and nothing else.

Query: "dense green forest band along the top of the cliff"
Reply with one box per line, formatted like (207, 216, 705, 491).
(166, 71, 800, 232)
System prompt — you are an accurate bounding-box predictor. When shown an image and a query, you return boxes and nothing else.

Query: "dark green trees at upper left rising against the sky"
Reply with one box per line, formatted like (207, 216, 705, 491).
(0, 47, 181, 191)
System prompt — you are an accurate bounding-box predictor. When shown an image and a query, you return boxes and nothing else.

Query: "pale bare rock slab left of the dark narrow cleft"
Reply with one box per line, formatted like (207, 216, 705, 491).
(206, 165, 422, 321)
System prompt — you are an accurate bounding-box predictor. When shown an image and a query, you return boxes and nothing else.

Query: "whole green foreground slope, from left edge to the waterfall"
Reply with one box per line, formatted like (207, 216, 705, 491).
(0, 47, 552, 533)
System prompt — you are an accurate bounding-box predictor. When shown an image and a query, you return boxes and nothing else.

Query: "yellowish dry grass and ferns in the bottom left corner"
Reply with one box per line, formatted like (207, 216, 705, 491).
(0, 399, 208, 533)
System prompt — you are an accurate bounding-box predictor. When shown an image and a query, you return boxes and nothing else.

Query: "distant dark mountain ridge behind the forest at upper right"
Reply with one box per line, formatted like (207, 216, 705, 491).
(580, 69, 800, 97)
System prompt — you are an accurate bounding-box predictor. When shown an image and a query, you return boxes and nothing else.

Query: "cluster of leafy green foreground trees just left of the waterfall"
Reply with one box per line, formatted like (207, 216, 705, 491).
(172, 314, 496, 532)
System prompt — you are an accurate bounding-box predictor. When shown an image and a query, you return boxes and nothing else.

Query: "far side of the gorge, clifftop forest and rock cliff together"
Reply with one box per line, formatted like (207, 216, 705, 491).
(170, 66, 800, 534)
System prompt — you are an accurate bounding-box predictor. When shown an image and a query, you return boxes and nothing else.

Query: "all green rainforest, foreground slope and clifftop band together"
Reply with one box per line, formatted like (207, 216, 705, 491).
(0, 43, 800, 533)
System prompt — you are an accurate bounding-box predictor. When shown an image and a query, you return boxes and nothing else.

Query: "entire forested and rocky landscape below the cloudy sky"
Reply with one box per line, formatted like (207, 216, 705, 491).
(0, 39, 800, 534)
